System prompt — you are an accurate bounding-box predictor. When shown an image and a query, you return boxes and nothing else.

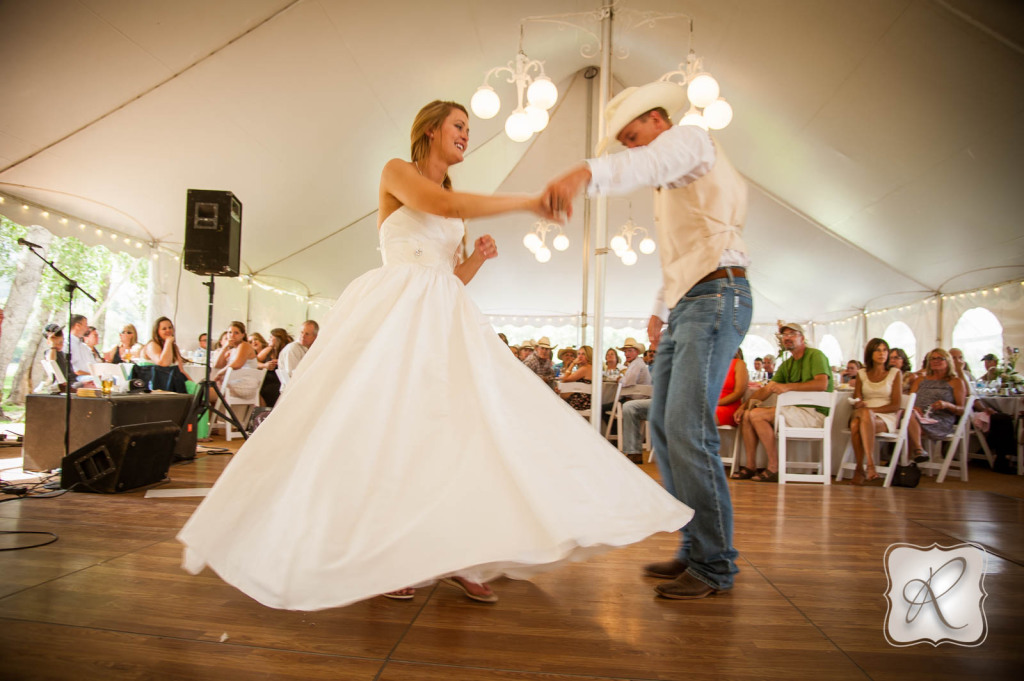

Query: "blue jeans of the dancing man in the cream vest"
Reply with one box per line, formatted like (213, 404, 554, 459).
(650, 275, 753, 589)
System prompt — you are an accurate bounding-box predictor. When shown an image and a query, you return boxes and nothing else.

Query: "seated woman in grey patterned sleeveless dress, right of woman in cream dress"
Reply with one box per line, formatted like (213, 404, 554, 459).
(907, 347, 967, 461)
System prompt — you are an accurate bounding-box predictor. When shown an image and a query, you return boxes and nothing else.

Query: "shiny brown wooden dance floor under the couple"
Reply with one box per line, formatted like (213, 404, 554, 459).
(0, 440, 1024, 681)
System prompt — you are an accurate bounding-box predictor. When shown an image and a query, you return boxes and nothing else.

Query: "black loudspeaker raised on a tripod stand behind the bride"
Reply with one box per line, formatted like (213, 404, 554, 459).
(184, 189, 242, 276)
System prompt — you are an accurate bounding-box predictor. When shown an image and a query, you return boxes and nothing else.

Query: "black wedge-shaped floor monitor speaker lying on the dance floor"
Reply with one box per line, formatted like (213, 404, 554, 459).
(60, 421, 181, 494)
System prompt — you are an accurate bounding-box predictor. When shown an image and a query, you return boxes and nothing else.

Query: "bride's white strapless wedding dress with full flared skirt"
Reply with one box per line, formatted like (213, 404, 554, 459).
(178, 207, 693, 610)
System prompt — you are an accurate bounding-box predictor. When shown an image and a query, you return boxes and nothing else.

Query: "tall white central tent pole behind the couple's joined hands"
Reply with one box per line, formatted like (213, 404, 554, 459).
(590, 2, 622, 436)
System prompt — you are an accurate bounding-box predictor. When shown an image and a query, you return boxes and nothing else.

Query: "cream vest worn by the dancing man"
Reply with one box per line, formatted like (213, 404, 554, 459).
(654, 143, 746, 309)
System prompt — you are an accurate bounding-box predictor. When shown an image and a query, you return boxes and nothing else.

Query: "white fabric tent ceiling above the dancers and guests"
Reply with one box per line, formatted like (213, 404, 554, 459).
(0, 0, 1024, 322)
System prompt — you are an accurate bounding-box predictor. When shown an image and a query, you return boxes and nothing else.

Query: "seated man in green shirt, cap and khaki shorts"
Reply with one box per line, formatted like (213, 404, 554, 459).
(732, 322, 833, 482)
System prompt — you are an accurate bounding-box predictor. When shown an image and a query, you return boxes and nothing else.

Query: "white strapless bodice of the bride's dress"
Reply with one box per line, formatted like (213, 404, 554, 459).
(380, 206, 466, 271)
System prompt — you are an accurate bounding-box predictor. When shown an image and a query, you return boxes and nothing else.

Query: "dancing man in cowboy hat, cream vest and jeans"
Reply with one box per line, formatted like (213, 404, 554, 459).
(545, 81, 753, 599)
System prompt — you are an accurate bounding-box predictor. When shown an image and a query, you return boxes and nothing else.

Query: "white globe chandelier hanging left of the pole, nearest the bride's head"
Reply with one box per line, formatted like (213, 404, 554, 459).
(469, 25, 558, 142)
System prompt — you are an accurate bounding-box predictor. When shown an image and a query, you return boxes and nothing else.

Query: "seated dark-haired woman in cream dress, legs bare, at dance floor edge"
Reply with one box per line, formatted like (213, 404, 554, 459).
(850, 338, 903, 484)
